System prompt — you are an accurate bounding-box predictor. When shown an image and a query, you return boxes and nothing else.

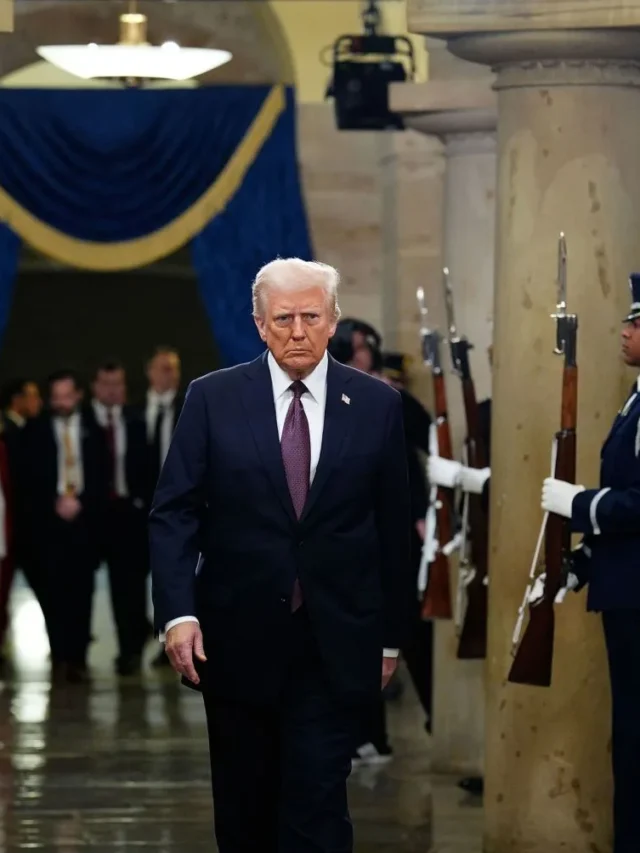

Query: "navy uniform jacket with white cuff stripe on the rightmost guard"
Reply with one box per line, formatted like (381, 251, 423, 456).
(571, 388, 640, 611)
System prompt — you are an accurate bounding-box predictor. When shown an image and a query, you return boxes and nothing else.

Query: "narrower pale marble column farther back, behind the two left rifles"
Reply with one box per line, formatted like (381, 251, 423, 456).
(392, 76, 496, 775)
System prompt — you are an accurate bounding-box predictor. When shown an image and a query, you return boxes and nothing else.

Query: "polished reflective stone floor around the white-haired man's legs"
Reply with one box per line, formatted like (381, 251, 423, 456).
(0, 577, 482, 853)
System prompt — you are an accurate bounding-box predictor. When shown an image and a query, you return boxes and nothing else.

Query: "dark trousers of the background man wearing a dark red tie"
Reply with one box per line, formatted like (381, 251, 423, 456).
(103, 499, 149, 659)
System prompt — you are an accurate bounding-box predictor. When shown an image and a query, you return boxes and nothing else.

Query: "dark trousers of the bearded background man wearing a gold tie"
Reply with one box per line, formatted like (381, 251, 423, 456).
(39, 514, 100, 666)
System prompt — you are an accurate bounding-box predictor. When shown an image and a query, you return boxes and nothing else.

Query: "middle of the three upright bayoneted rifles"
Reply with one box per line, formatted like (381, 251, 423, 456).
(444, 269, 489, 660)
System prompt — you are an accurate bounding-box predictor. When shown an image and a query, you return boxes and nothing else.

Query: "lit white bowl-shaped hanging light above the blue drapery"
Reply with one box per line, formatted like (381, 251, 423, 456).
(36, 0, 231, 85)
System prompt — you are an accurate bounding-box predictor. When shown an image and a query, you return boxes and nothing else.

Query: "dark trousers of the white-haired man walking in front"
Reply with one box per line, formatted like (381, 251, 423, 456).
(204, 612, 361, 853)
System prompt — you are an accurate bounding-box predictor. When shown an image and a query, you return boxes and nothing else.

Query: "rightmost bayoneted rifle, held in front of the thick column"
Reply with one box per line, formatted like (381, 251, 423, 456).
(508, 234, 578, 687)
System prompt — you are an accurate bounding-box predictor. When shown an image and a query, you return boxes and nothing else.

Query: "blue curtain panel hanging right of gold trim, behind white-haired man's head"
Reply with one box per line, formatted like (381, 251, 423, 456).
(192, 92, 312, 365)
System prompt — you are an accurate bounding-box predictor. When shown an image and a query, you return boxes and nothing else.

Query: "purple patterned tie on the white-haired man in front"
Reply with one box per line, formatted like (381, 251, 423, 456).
(280, 379, 311, 613)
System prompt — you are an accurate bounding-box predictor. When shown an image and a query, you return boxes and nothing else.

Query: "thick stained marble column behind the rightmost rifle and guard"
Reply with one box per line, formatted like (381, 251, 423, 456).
(410, 13, 640, 853)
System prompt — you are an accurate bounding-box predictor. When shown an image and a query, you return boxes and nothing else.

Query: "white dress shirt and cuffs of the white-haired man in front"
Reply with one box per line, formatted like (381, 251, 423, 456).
(160, 352, 398, 657)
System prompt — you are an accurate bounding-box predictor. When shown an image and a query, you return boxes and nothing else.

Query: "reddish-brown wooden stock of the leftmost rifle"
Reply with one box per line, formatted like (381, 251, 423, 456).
(421, 372, 453, 619)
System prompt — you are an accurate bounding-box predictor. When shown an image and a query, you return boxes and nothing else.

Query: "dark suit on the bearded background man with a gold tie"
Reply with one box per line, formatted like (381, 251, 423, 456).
(16, 413, 108, 669)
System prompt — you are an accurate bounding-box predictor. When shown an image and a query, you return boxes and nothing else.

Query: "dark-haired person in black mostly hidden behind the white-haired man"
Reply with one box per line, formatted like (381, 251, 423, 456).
(329, 318, 433, 765)
